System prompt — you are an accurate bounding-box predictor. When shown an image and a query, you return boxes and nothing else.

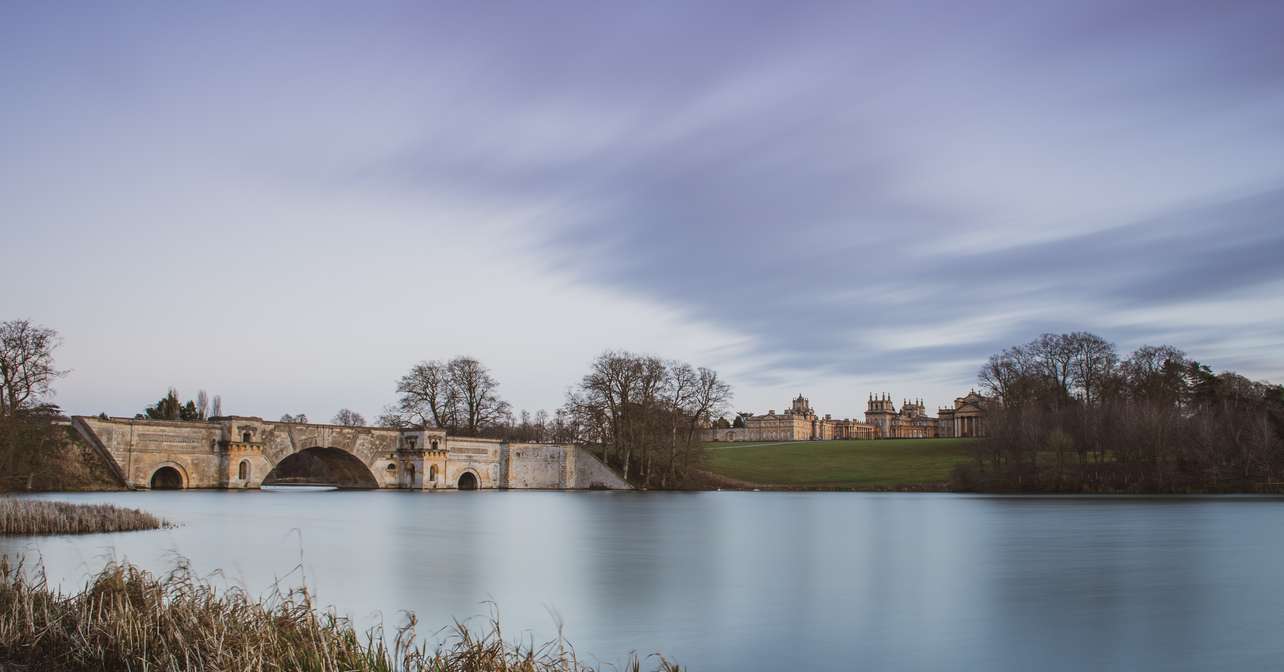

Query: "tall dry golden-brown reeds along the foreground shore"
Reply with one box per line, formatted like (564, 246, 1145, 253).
(0, 558, 679, 672)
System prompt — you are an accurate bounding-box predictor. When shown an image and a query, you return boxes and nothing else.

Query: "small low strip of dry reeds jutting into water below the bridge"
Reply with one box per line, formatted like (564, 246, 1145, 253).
(0, 497, 172, 535)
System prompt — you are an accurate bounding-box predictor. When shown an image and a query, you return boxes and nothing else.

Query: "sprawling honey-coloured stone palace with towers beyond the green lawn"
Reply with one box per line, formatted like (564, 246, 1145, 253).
(702, 391, 987, 442)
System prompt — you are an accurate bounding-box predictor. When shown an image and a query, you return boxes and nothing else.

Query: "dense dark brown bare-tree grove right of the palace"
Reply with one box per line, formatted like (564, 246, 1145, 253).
(955, 332, 1284, 492)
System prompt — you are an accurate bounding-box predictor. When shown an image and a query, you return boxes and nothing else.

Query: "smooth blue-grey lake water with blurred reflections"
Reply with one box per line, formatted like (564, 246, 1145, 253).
(0, 492, 1284, 671)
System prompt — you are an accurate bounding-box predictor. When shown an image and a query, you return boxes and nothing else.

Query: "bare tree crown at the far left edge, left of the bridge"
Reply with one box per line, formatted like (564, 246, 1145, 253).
(0, 320, 67, 416)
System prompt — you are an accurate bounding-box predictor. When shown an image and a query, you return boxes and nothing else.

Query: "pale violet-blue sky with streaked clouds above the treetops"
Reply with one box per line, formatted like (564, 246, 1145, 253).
(0, 0, 1284, 420)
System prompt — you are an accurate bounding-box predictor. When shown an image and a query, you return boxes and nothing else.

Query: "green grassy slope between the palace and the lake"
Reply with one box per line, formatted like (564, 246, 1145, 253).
(705, 438, 975, 488)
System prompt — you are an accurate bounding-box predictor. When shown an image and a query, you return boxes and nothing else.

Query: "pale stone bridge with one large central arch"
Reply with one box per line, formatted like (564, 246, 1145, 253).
(72, 415, 629, 490)
